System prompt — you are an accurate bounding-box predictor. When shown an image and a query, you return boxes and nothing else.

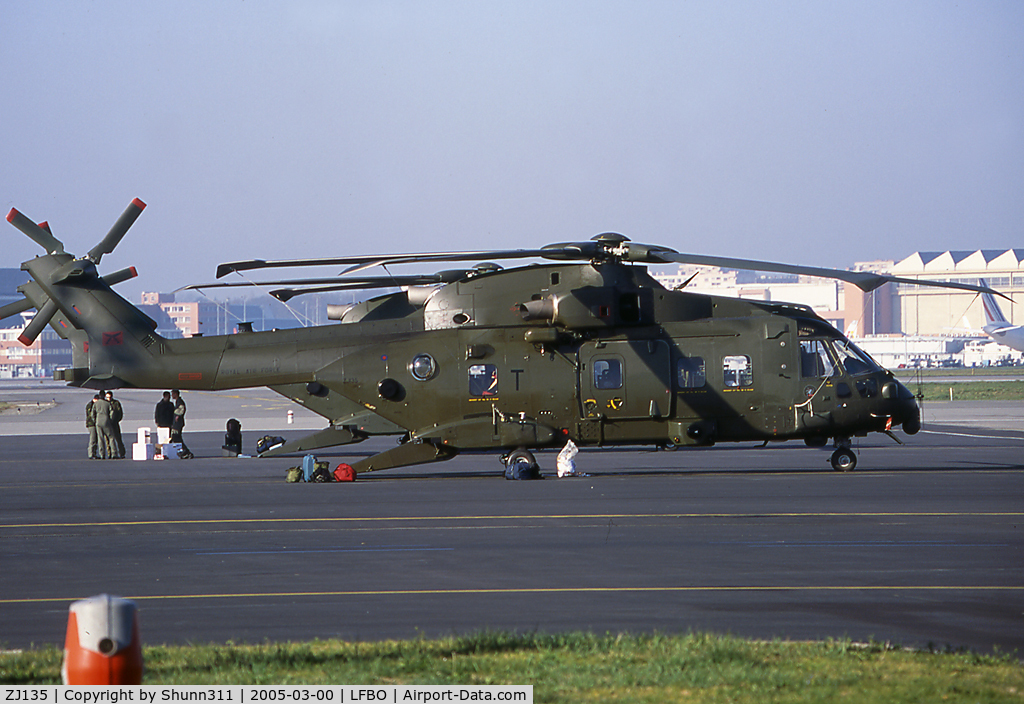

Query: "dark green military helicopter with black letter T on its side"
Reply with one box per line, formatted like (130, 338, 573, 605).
(0, 199, 995, 477)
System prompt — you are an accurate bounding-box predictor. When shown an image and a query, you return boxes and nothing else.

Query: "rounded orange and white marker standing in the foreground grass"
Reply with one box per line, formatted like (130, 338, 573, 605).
(60, 595, 142, 685)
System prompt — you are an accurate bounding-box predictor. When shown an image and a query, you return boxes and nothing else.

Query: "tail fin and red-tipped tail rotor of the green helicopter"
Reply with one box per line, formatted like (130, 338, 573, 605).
(0, 199, 167, 389)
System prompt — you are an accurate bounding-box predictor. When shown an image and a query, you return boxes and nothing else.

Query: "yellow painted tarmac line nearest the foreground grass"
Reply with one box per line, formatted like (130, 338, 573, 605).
(0, 584, 1024, 605)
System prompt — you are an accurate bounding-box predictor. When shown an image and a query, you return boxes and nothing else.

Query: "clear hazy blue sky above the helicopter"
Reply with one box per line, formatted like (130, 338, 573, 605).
(0, 0, 1024, 298)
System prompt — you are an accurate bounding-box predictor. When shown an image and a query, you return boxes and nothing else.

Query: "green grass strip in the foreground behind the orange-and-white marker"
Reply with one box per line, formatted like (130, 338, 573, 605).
(0, 632, 1024, 704)
